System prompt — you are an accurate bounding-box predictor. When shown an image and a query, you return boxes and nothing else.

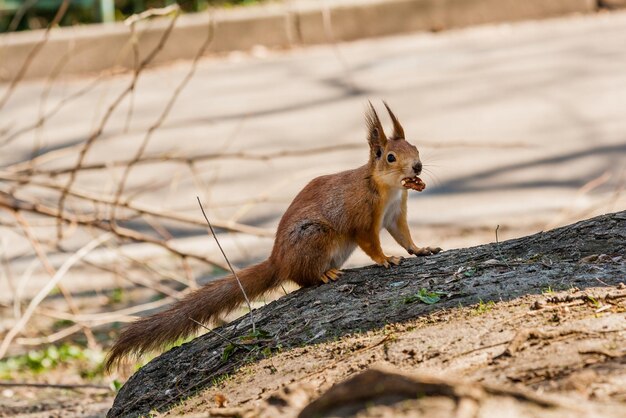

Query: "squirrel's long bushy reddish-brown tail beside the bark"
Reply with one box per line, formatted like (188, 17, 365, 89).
(105, 260, 278, 371)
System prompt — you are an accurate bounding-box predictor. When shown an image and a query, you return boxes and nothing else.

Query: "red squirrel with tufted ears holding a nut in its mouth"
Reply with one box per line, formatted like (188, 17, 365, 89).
(105, 102, 441, 371)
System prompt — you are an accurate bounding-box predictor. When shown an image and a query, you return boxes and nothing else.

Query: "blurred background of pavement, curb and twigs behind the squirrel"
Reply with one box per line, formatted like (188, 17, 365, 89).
(0, 0, 626, 416)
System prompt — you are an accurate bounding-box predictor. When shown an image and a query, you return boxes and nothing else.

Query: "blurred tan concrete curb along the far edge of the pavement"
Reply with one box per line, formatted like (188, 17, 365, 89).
(0, 0, 597, 80)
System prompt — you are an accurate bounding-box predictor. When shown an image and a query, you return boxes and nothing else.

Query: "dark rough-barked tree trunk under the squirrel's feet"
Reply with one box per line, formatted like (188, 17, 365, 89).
(108, 211, 626, 417)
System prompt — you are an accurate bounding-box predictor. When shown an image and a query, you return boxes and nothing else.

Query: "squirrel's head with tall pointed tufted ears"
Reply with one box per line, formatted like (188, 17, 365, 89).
(365, 102, 422, 188)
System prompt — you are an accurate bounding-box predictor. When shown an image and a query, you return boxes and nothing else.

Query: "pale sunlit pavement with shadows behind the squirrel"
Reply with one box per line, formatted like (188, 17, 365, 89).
(0, 12, 626, 302)
